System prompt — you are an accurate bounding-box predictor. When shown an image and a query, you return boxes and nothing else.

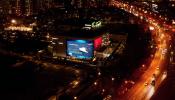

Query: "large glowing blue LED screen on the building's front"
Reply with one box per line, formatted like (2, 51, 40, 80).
(67, 40, 94, 59)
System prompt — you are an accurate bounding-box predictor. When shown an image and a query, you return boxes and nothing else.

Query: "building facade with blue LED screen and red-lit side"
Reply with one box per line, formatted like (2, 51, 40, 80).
(48, 33, 110, 60)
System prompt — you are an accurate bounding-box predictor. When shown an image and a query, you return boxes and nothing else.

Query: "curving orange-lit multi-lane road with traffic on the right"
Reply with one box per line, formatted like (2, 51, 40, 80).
(111, 0, 170, 100)
